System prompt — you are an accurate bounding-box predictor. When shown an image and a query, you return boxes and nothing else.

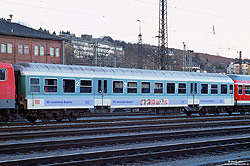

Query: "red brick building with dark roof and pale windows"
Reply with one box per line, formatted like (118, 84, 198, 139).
(0, 19, 63, 64)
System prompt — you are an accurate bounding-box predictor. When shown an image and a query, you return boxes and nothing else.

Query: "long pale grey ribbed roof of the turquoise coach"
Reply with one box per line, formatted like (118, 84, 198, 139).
(14, 63, 233, 83)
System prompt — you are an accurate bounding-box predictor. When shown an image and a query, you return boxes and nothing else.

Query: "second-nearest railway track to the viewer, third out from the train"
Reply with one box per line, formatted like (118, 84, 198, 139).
(0, 127, 250, 154)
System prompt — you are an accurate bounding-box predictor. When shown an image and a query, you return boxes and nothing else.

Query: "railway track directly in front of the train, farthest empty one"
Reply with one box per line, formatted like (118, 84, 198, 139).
(0, 116, 250, 133)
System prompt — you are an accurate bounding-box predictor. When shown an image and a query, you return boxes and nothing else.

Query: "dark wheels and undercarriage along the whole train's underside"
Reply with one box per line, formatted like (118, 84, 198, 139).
(0, 106, 250, 123)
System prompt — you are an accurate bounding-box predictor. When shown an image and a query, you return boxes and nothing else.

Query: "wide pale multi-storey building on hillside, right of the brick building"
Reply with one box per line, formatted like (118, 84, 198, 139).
(60, 32, 125, 67)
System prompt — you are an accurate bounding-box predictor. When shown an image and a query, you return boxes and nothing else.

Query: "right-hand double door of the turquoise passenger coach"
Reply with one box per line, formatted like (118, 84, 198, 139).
(188, 82, 199, 106)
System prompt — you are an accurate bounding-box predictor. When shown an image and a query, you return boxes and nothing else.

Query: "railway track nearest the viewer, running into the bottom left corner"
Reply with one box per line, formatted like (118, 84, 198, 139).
(0, 137, 250, 166)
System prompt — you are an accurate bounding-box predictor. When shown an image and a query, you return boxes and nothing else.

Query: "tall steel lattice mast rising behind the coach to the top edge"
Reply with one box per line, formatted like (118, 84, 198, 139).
(158, 0, 168, 70)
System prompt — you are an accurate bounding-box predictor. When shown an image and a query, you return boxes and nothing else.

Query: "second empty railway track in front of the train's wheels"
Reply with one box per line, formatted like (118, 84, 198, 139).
(0, 120, 250, 141)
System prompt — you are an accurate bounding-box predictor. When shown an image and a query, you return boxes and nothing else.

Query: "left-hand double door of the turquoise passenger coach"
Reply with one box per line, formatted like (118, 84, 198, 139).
(95, 78, 110, 107)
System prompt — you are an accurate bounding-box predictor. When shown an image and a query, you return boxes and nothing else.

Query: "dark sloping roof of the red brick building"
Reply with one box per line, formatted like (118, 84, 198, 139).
(0, 19, 64, 41)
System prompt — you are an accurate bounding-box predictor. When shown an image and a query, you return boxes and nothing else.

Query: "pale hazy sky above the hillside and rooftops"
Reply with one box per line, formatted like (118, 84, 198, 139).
(0, 0, 250, 59)
